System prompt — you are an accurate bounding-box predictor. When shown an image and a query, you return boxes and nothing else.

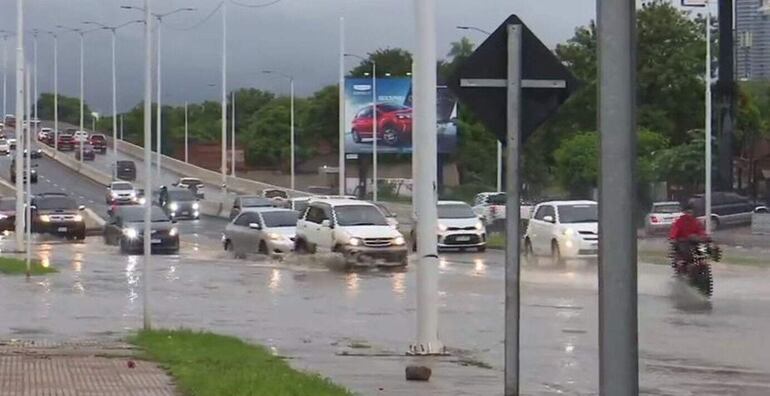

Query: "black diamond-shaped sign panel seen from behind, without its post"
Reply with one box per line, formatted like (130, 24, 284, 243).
(448, 15, 578, 144)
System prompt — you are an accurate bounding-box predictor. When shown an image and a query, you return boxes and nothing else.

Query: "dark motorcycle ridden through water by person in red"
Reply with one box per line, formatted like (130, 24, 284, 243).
(670, 241, 722, 297)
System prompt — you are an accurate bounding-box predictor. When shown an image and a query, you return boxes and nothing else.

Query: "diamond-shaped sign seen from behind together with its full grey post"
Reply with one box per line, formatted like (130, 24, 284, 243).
(450, 15, 577, 396)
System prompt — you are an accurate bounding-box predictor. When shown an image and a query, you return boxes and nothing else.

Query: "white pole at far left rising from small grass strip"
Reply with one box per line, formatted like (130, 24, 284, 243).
(14, 0, 25, 251)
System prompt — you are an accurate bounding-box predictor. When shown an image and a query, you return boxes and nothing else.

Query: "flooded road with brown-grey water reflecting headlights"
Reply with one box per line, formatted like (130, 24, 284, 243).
(0, 237, 770, 395)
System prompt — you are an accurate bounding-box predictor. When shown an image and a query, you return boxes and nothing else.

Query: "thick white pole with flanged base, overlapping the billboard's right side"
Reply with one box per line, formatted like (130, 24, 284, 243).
(410, 0, 444, 354)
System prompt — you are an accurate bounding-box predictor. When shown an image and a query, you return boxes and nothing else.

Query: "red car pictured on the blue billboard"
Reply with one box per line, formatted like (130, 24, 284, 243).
(351, 103, 412, 146)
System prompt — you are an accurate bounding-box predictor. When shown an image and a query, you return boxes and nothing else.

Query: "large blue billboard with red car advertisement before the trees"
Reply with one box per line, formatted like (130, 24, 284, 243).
(345, 77, 457, 154)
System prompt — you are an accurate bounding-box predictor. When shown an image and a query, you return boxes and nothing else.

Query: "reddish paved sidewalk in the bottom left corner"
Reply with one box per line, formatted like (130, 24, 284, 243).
(0, 341, 177, 396)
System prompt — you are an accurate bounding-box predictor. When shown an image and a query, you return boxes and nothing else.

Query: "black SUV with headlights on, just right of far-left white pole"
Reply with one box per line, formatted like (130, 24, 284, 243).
(30, 193, 86, 240)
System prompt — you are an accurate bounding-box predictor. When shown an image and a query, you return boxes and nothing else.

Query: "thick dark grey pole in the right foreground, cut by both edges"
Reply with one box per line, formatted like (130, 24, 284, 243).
(597, 0, 639, 396)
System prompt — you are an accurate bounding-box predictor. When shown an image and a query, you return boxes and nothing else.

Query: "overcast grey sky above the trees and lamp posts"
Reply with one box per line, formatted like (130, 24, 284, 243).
(0, 0, 596, 112)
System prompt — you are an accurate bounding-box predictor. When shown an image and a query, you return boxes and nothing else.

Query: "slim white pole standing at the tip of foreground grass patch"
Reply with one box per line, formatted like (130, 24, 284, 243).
(142, 0, 153, 330)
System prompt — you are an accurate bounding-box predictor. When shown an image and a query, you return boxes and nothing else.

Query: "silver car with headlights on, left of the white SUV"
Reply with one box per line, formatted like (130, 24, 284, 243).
(222, 208, 299, 257)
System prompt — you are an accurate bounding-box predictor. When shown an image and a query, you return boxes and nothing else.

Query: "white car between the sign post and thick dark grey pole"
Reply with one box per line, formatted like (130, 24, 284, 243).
(524, 201, 599, 263)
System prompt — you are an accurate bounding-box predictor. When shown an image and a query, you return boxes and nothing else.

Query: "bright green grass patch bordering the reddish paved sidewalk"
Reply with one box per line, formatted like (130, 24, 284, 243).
(130, 330, 352, 396)
